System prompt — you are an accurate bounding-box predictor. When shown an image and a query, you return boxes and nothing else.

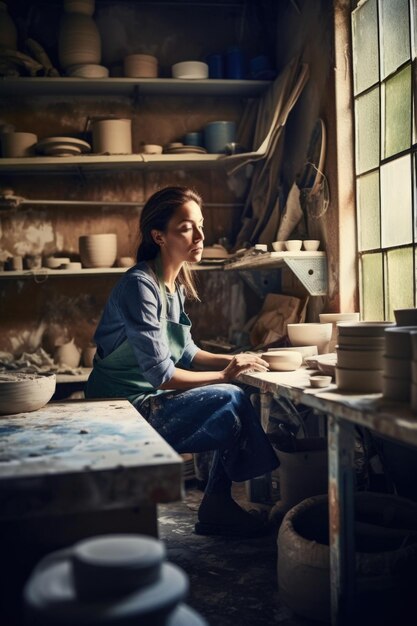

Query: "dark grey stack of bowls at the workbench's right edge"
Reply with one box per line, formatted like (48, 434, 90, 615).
(383, 326, 417, 401)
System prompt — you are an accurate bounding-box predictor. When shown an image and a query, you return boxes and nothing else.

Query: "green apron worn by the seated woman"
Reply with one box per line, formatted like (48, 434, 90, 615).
(85, 263, 191, 407)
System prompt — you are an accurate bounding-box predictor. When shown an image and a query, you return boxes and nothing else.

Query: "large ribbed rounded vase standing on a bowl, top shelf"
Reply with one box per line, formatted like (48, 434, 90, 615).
(58, 13, 101, 68)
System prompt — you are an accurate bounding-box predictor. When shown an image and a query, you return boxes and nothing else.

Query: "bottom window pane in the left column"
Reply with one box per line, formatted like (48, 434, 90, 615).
(361, 252, 384, 321)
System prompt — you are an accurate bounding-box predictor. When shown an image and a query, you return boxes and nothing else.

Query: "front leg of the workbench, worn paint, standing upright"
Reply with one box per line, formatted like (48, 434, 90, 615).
(328, 416, 355, 626)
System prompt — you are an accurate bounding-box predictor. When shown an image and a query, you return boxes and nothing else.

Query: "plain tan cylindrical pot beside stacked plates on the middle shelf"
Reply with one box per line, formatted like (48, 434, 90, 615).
(91, 119, 132, 154)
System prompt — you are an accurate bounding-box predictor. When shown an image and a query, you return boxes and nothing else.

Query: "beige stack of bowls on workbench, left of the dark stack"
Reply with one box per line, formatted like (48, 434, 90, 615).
(336, 322, 393, 393)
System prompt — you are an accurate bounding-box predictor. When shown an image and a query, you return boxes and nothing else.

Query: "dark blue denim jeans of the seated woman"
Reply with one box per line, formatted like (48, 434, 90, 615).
(138, 384, 279, 493)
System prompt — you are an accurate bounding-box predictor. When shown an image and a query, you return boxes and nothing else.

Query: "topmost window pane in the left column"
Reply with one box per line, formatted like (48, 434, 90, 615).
(352, 0, 379, 94)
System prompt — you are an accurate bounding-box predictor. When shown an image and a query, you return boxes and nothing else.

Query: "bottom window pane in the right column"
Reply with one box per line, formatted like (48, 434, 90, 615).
(385, 246, 414, 321)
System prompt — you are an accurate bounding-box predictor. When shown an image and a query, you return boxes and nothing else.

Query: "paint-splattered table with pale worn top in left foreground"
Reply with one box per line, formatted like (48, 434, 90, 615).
(0, 400, 182, 530)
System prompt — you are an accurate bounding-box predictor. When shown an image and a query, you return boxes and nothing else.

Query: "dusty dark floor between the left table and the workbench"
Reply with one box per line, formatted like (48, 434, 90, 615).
(158, 485, 318, 626)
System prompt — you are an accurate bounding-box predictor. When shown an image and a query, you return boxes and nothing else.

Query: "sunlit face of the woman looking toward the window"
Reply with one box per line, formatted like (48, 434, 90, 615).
(157, 200, 204, 263)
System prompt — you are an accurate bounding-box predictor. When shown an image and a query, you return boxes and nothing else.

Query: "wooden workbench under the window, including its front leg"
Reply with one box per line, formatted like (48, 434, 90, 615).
(239, 367, 417, 626)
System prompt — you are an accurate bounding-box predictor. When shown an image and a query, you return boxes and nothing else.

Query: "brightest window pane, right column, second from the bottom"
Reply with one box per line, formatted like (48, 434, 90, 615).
(381, 155, 413, 248)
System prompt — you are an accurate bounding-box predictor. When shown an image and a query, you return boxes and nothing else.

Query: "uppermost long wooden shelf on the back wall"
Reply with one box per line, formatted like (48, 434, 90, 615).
(0, 76, 271, 97)
